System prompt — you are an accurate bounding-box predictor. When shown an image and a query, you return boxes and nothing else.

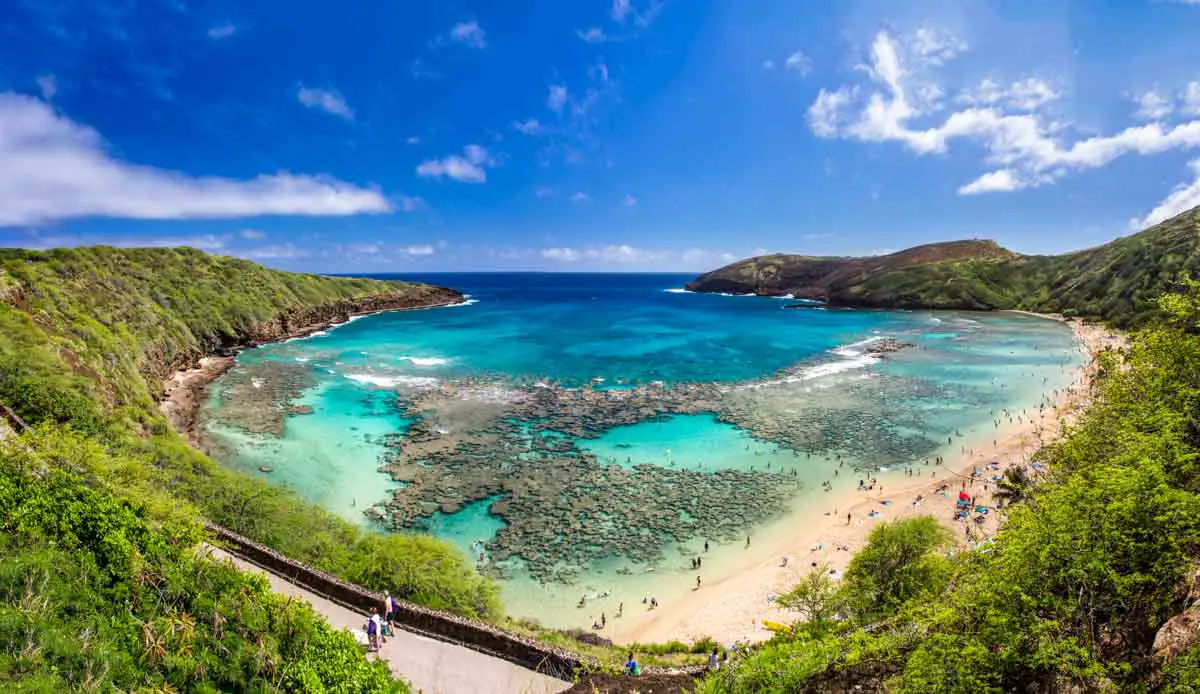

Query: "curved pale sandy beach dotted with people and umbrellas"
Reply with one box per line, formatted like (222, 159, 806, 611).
(612, 316, 1124, 644)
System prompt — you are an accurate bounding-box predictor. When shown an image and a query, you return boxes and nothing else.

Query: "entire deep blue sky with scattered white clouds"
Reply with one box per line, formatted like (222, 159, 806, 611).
(0, 0, 1200, 273)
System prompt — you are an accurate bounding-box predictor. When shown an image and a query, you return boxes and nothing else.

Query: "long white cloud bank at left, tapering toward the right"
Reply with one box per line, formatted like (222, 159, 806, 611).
(0, 94, 392, 226)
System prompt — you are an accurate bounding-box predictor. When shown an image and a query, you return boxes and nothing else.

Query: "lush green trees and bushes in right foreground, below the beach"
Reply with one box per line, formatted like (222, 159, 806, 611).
(700, 282, 1200, 694)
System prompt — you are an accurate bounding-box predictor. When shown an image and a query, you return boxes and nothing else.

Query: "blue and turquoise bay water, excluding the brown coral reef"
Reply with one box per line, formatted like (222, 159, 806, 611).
(205, 274, 1080, 626)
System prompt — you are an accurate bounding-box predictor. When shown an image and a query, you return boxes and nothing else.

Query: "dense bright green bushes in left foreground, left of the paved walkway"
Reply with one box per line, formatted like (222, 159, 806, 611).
(0, 430, 408, 693)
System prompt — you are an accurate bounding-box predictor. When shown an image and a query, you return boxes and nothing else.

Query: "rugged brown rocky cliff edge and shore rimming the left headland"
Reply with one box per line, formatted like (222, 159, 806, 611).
(158, 286, 467, 453)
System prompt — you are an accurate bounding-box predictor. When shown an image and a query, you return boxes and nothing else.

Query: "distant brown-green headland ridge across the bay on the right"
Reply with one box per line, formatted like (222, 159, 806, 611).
(688, 208, 1200, 325)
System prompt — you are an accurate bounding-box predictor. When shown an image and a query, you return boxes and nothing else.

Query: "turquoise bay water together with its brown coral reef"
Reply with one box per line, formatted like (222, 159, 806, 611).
(204, 274, 1080, 626)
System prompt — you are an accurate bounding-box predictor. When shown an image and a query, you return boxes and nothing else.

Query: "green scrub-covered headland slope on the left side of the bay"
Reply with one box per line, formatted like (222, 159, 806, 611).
(0, 246, 463, 420)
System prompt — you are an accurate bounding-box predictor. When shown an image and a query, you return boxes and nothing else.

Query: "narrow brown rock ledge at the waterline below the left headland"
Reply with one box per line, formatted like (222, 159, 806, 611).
(158, 295, 472, 441)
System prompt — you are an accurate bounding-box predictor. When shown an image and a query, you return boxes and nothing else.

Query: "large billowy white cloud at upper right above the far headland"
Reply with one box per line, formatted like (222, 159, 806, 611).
(809, 31, 1200, 195)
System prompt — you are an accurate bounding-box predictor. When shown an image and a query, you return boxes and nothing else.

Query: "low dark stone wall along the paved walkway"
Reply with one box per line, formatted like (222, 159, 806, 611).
(208, 525, 584, 682)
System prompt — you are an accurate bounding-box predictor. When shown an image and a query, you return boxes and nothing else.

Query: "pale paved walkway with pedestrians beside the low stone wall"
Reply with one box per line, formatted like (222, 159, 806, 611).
(208, 548, 571, 694)
